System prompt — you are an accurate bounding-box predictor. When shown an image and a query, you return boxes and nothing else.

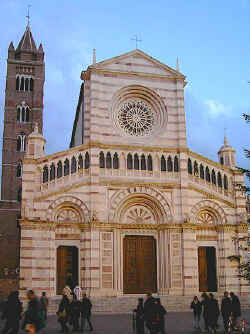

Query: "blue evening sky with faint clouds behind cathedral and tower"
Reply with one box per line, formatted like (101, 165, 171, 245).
(0, 0, 250, 183)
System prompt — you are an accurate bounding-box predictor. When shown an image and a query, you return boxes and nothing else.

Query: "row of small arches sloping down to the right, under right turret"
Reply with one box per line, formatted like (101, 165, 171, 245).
(188, 158, 228, 190)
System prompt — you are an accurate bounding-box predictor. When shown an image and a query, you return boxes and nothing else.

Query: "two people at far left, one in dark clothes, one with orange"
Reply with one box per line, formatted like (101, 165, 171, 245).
(2, 290, 48, 334)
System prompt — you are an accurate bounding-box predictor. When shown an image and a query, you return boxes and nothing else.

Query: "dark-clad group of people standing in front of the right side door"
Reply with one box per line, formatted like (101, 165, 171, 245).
(190, 291, 241, 333)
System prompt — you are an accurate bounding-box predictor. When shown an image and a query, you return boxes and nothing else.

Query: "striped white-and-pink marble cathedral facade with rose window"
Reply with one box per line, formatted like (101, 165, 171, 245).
(20, 45, 249, 296)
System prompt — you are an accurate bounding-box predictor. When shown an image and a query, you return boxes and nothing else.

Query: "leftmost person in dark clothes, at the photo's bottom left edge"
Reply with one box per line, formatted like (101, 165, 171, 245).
(2, 291, 23, 334)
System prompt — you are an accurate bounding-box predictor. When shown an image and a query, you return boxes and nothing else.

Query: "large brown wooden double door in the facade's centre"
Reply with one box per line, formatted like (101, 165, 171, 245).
(123, 236, 157, 294)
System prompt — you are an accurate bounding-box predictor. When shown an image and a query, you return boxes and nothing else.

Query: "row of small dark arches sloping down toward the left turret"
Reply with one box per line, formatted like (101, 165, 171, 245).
(43, 152, 90, 183)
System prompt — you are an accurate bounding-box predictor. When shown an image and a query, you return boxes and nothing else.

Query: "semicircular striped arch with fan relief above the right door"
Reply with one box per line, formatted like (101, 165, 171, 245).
(191, 200, 227, 225)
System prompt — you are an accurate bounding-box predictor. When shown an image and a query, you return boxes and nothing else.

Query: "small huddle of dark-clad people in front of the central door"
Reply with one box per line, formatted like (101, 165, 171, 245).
(134, 293, 167, 334)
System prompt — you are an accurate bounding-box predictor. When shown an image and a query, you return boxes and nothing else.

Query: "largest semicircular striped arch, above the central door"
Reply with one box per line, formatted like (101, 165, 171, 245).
(109, 187, 172, 224)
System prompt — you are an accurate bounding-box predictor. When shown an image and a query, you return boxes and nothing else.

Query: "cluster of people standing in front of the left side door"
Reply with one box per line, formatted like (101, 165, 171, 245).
(57, 286, 93, 333)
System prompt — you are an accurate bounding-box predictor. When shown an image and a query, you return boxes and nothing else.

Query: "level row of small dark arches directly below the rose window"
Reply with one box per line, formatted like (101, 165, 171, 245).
(99, 151, 179, 172)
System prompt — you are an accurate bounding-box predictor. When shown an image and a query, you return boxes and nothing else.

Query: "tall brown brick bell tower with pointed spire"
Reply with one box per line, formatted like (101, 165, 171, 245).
(1, 24, 44, 201)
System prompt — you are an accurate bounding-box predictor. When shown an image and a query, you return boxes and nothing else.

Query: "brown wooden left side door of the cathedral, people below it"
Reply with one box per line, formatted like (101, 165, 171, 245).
(57, 246, 79, 294)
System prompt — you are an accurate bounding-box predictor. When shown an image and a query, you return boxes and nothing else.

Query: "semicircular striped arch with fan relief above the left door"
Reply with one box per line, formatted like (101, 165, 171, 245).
(47, 196, 89, 223)
